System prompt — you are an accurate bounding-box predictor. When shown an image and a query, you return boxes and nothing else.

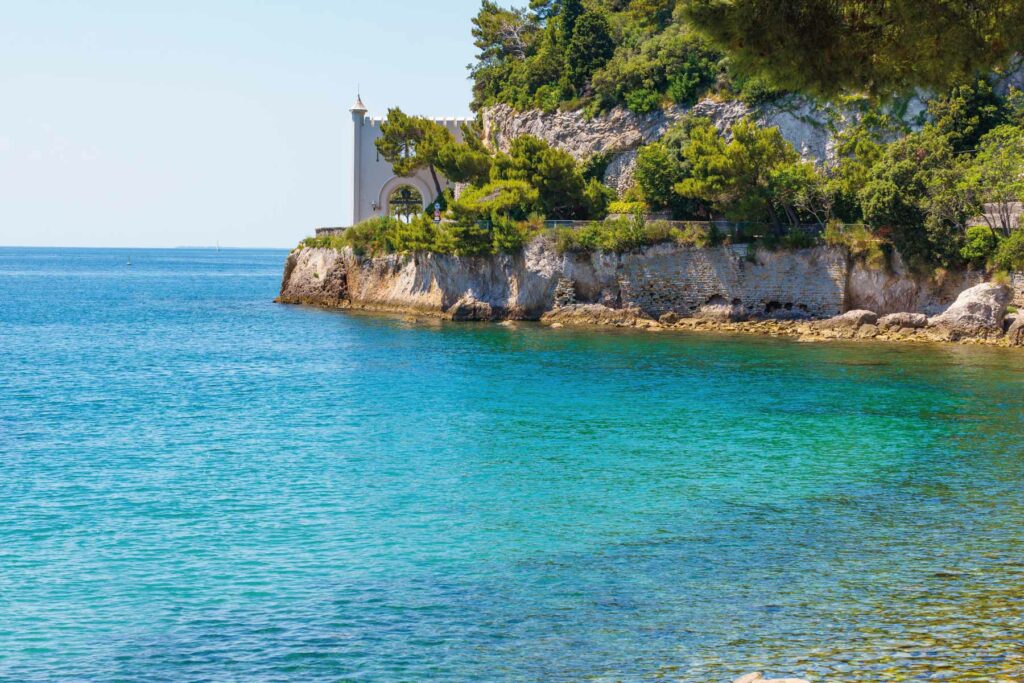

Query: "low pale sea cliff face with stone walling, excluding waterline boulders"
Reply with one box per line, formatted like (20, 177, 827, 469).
(279, 238, 982, 327)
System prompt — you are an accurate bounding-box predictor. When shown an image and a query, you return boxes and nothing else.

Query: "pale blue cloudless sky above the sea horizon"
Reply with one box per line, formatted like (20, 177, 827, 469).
(0, 0, 479, 247)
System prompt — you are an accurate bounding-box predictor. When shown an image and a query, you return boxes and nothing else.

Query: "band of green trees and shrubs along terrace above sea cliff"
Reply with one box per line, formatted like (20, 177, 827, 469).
(358, 80, 1024, 269)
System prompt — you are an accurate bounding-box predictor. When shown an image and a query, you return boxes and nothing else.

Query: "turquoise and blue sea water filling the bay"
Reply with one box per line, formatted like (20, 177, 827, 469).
(0, 249, 1024, 683)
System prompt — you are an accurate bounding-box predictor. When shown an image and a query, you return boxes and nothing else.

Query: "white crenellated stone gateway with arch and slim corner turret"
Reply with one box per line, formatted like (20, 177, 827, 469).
(348, 97, 469, 225)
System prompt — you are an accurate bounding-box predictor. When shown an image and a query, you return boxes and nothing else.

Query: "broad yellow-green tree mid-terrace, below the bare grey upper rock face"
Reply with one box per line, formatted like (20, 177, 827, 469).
(676, 119, 800, 226)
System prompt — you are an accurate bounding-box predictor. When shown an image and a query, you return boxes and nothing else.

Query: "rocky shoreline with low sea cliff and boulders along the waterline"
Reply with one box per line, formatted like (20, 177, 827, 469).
(276, 241, 1024, 346)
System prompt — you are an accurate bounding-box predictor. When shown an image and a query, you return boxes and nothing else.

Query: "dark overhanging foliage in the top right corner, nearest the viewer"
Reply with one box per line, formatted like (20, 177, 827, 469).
(682, 0, 1024, 97)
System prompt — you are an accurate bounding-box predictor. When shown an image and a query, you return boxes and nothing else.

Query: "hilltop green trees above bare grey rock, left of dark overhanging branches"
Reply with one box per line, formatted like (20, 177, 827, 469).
(470, 0, 728, 113)
